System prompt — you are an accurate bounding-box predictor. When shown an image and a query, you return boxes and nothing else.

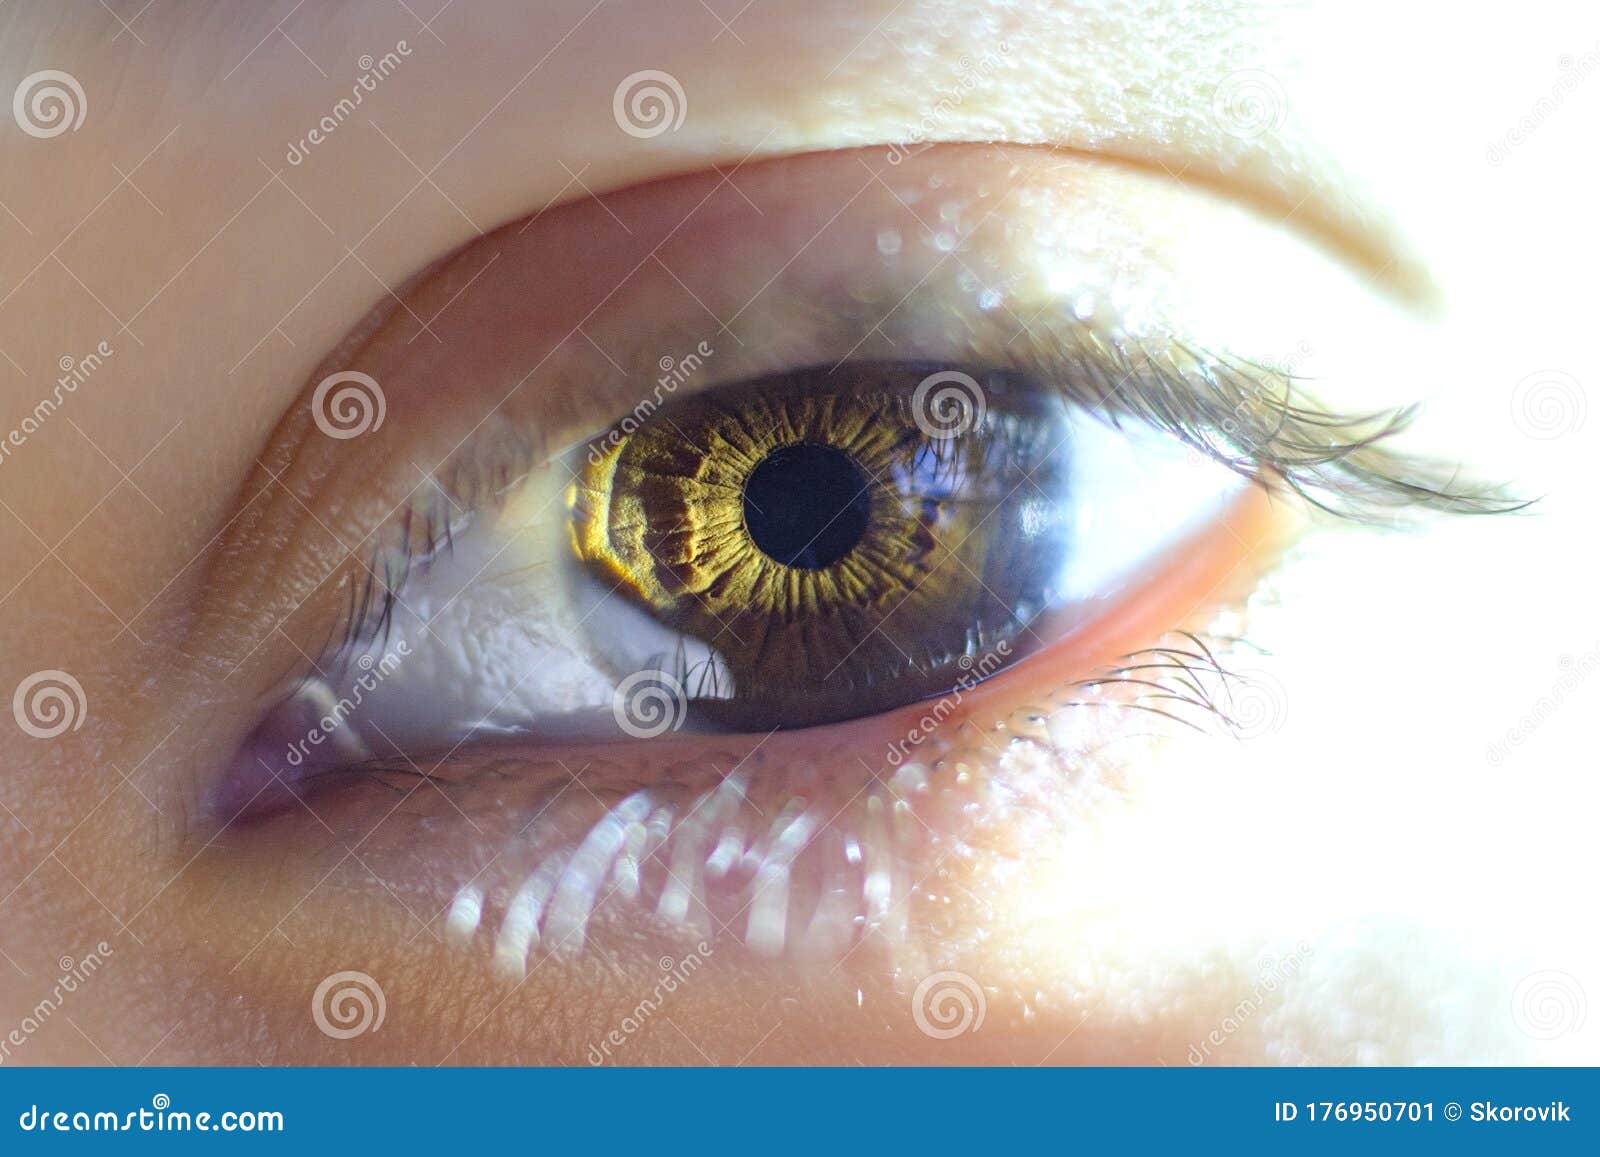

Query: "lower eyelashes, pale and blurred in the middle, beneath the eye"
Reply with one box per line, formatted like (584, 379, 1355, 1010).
(275, 632, 1280, 981)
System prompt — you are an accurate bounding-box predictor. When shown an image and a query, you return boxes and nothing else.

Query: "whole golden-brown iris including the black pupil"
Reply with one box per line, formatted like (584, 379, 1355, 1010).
(568, 363, 1070, 727)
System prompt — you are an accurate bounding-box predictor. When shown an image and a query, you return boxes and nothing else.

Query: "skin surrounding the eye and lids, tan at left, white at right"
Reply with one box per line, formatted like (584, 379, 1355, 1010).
(0, 0, 1600, 1064)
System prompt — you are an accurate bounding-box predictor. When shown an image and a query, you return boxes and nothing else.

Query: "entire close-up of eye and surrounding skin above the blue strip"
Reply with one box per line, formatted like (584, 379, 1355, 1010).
(12, 0, 1568, 1068)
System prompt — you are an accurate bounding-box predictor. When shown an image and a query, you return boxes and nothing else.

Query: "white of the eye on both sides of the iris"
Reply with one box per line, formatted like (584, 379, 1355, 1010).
(291, 411, 1248, 755)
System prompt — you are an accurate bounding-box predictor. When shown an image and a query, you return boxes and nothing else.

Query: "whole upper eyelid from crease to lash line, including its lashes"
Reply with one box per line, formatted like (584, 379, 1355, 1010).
(225, 140, 1515, 729)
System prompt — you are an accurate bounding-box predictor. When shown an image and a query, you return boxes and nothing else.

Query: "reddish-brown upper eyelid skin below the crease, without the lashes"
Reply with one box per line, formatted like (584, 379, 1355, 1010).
(195, 149, 1472, 787)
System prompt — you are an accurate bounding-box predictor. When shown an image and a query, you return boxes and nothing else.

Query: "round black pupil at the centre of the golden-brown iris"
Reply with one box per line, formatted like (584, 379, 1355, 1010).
(744, 443, 872, 570)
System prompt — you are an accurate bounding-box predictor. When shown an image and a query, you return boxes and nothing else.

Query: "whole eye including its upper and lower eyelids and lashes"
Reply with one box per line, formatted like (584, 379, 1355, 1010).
(181, 138, 1502, 1000)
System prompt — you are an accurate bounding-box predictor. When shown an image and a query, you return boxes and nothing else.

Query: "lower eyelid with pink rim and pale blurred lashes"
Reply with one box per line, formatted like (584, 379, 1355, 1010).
(206, 488, 1277, 979)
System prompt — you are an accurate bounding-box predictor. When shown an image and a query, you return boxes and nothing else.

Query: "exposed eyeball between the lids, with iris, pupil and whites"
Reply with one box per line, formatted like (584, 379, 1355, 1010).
(228, 353, 1245, 768)
